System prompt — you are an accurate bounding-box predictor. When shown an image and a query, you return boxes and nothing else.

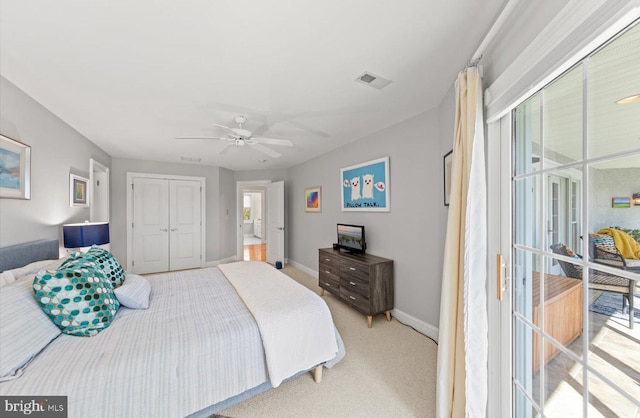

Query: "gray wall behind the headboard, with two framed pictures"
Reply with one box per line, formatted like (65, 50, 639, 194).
(0, 77, 111, 247)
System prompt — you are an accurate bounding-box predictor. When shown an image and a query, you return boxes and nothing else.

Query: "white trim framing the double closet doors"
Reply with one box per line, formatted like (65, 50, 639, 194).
(127, 172, 207, 271)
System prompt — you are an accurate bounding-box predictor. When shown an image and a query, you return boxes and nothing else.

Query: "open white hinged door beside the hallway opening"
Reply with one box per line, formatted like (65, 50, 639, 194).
(266, 181, 284, 264)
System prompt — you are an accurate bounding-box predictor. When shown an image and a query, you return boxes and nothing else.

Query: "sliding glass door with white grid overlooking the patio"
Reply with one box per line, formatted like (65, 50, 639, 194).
(506, 18, 640, 418)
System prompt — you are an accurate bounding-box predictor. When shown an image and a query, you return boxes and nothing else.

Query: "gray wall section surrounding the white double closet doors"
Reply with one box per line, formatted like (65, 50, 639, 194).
(111, 158, 235, 265)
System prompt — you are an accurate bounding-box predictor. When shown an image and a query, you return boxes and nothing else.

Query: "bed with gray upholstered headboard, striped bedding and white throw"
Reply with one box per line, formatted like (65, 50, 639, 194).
(0, 241, 344, 417)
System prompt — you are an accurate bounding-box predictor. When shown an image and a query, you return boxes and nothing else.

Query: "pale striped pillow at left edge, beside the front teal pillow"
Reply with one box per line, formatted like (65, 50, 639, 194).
(0, 280, 61, 382)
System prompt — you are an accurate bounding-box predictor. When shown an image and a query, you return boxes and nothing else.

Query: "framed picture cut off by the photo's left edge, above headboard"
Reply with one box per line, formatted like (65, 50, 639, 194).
(0, 135, 31, 199)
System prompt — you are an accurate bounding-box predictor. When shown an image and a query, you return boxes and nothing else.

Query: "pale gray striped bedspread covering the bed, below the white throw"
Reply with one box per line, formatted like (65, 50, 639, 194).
(0, 263, 339, 418)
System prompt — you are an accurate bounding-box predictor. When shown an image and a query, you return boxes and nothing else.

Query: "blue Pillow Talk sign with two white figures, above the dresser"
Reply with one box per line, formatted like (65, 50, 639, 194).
(340, 157, 390, 212)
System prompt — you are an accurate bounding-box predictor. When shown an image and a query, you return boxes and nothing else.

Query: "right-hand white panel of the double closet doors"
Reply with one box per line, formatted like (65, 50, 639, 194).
(169, 180, 202, 270)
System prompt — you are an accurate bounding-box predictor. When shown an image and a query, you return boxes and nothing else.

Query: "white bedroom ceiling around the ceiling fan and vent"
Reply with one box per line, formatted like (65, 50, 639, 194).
(0, 0, 504, 170)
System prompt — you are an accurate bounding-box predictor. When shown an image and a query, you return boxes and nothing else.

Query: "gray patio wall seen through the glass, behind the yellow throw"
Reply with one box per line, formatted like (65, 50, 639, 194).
(589, 168, 640, 232)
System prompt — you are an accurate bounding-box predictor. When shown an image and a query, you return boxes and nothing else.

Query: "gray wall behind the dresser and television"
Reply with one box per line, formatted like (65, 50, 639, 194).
(288, 109, 444, 327)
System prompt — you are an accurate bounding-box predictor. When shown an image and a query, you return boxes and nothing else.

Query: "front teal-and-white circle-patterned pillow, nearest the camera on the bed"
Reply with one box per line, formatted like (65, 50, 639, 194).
(33, 265, 120, 337)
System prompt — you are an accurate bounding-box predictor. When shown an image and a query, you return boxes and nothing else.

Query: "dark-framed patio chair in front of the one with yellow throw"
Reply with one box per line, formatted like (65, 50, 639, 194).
(550, 244, 636, 329)
